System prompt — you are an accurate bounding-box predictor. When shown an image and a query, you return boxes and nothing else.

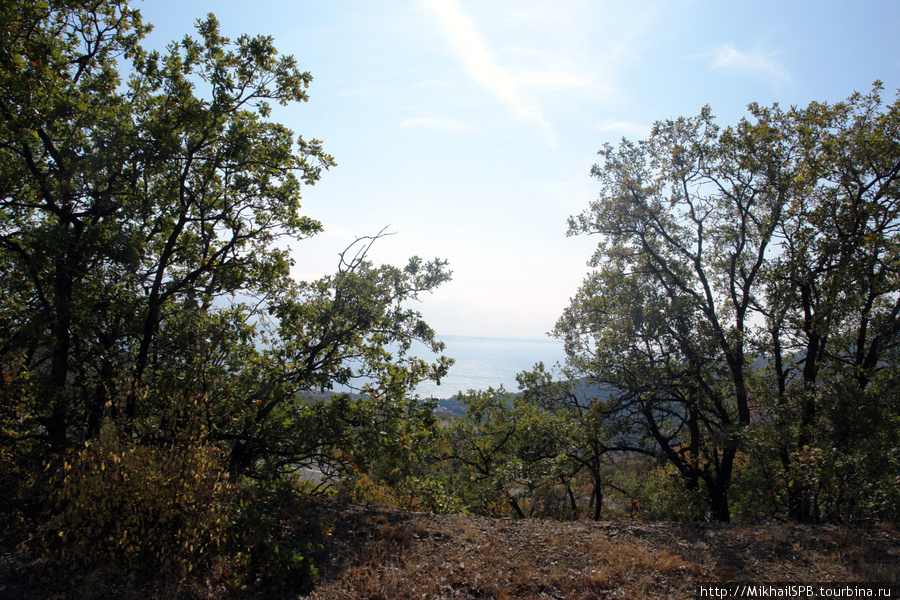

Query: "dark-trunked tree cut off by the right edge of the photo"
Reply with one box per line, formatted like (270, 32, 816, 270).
(751, 82, 900, 521)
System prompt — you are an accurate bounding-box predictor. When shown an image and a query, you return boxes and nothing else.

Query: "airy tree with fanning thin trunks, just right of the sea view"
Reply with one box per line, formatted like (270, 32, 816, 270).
(556, 110, 785, 521)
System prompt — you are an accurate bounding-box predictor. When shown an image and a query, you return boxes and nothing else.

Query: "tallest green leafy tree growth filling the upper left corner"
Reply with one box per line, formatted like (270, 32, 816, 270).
(0, 0, 316, 452)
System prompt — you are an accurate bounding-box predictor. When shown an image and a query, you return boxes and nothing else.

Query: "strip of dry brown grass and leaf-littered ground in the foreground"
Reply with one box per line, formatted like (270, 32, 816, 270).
(298, 501, 900, 600)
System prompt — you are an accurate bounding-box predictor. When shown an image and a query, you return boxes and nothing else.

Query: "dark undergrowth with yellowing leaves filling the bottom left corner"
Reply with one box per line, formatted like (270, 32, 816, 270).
(2, 435, 321, 598)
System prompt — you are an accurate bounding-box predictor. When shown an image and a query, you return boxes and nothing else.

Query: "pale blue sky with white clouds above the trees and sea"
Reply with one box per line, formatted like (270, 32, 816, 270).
(136, 0, 900, 339)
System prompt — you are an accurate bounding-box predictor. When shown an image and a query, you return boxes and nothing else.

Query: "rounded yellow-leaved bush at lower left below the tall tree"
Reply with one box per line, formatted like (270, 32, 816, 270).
(30, 427, 233, 580)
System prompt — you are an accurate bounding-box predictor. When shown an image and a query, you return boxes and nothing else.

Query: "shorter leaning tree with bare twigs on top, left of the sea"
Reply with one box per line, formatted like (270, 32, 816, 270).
(215, 236, 452, 474)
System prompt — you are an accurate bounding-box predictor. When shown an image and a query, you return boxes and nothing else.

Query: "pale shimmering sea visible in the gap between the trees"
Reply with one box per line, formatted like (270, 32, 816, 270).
(416, 335, 566, 398)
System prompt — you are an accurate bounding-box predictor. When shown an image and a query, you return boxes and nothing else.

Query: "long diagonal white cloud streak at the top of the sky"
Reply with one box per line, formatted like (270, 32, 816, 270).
(425, 0, 556, 145)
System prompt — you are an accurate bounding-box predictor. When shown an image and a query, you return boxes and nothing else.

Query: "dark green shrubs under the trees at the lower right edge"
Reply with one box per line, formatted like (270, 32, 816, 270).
(733, 370, 900, 522)
